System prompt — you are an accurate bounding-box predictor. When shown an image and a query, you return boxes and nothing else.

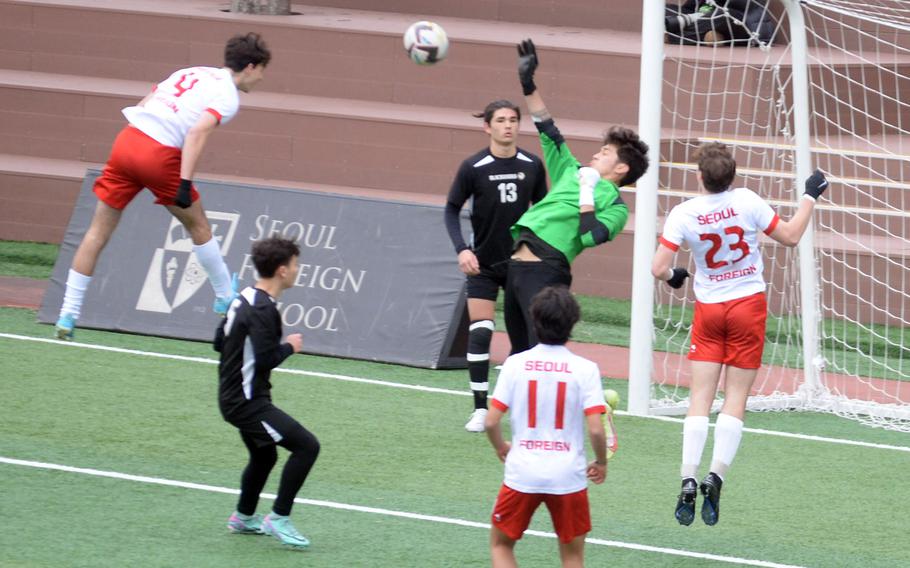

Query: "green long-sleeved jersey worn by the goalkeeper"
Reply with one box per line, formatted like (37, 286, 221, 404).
(512, 120, 629, 264)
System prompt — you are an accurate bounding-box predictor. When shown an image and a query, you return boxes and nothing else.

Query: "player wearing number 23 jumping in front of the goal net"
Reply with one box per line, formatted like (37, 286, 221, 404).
(651, 142, 828, 525)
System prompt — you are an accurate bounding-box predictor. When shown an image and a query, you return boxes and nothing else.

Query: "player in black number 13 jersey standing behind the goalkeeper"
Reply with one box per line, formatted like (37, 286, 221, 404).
(445, 100, 547, 432)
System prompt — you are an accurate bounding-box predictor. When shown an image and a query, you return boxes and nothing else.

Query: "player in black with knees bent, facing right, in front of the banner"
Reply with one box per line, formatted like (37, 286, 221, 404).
(214, 238, 319, 548)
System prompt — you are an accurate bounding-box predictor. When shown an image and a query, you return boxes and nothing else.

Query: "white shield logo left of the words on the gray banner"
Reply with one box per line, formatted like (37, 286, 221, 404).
(136, 211, 240, 314)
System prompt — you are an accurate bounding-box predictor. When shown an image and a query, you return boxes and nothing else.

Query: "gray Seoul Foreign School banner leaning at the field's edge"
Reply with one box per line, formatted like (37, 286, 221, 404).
(38, 170, 467, 368)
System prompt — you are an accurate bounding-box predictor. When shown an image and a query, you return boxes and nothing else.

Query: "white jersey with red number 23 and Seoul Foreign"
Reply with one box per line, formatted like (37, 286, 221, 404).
(660, 187, 780, 304)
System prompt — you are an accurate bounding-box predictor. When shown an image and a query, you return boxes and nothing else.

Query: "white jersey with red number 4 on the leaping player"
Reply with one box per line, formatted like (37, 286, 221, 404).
(123, 67, 240, 148)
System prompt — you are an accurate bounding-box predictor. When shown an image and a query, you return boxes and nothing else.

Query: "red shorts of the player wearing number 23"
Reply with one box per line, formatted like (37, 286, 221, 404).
(689, 292, 768, 369)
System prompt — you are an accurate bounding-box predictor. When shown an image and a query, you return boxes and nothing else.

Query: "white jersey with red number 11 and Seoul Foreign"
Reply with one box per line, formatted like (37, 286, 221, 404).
(491, 344, 607, 495)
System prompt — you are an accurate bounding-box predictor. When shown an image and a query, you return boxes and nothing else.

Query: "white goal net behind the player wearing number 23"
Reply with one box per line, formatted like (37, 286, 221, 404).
(633, 0, 910, 430)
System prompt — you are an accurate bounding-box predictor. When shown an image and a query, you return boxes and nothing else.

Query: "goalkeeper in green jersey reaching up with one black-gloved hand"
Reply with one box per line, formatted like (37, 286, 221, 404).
(504, 39, 648, 353)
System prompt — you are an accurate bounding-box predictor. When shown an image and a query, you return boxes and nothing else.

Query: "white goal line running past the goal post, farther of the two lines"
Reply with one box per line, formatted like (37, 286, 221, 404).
(0, 333, 910, 453)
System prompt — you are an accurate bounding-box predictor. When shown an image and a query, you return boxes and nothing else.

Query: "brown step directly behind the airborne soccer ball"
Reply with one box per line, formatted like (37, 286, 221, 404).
(0, 0, 641, 125)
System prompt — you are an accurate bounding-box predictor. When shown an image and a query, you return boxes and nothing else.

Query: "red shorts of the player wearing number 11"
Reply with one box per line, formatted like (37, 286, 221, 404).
(491, 485, 591, 543)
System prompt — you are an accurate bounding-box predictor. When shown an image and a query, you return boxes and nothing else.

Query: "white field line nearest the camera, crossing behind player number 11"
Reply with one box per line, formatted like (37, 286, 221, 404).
(0, 458, 801, 568)
